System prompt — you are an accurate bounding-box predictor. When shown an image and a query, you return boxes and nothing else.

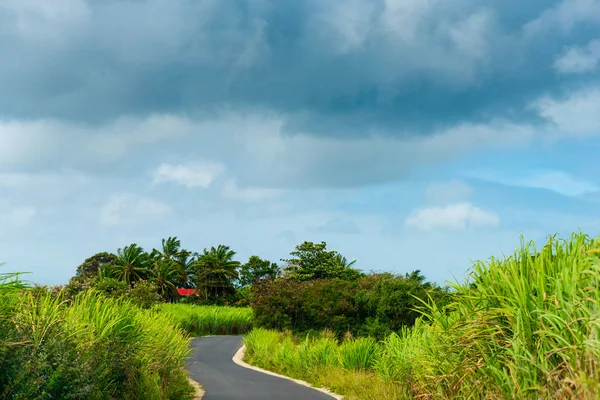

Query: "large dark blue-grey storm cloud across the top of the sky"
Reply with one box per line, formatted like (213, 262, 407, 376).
(0, 0, 599, 136)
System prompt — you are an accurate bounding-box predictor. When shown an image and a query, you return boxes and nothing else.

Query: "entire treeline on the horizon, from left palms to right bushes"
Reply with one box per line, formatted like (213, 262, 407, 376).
(66, 237, 449, 338)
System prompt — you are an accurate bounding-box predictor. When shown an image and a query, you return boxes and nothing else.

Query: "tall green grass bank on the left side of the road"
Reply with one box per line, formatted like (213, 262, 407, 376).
(0, 289, 191, 399)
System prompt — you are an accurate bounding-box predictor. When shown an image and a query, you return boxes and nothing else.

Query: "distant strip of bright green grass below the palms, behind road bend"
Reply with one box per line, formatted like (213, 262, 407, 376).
(155, 304, 254, 336)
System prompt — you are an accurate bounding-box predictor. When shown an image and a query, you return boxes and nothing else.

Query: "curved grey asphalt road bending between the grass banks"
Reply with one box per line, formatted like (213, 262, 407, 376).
(187, 336, 333, 400)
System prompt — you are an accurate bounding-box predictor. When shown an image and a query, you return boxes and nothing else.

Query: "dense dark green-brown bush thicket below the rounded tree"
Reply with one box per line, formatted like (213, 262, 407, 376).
(251, 271, 449, 338)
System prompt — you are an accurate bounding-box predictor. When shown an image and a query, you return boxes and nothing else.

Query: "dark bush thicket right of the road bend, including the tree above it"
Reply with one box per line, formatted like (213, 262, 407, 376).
(250, 242, 451, 338)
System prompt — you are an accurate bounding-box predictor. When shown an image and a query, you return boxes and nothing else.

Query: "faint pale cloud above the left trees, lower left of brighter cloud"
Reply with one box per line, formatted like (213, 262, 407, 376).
(98, 193, 171, 227)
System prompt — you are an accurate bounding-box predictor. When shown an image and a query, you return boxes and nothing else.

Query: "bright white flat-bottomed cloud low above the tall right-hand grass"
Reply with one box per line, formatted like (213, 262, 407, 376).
(405, 202, 500, 231)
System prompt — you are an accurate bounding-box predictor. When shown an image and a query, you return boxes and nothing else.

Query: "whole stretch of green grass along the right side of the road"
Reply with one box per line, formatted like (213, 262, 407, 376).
(246, 234, 600, 399)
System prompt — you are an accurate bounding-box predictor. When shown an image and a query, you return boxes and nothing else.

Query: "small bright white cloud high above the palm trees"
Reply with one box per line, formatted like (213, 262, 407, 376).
(154, 163, 225, 189)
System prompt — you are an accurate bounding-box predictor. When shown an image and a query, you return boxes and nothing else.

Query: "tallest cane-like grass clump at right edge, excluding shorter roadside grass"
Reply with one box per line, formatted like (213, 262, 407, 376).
(392, 234, 600, 399)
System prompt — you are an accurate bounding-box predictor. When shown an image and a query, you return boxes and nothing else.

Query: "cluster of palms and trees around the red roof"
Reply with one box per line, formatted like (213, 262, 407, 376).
(66, 237, 281, 306)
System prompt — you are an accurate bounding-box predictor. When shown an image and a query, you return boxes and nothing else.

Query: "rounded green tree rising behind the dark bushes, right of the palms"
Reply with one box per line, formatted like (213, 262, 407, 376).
(282, 242, 362, 281)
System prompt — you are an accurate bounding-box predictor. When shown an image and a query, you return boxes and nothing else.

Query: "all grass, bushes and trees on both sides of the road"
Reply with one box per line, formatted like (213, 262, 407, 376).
(0, 230, 600, 399)
